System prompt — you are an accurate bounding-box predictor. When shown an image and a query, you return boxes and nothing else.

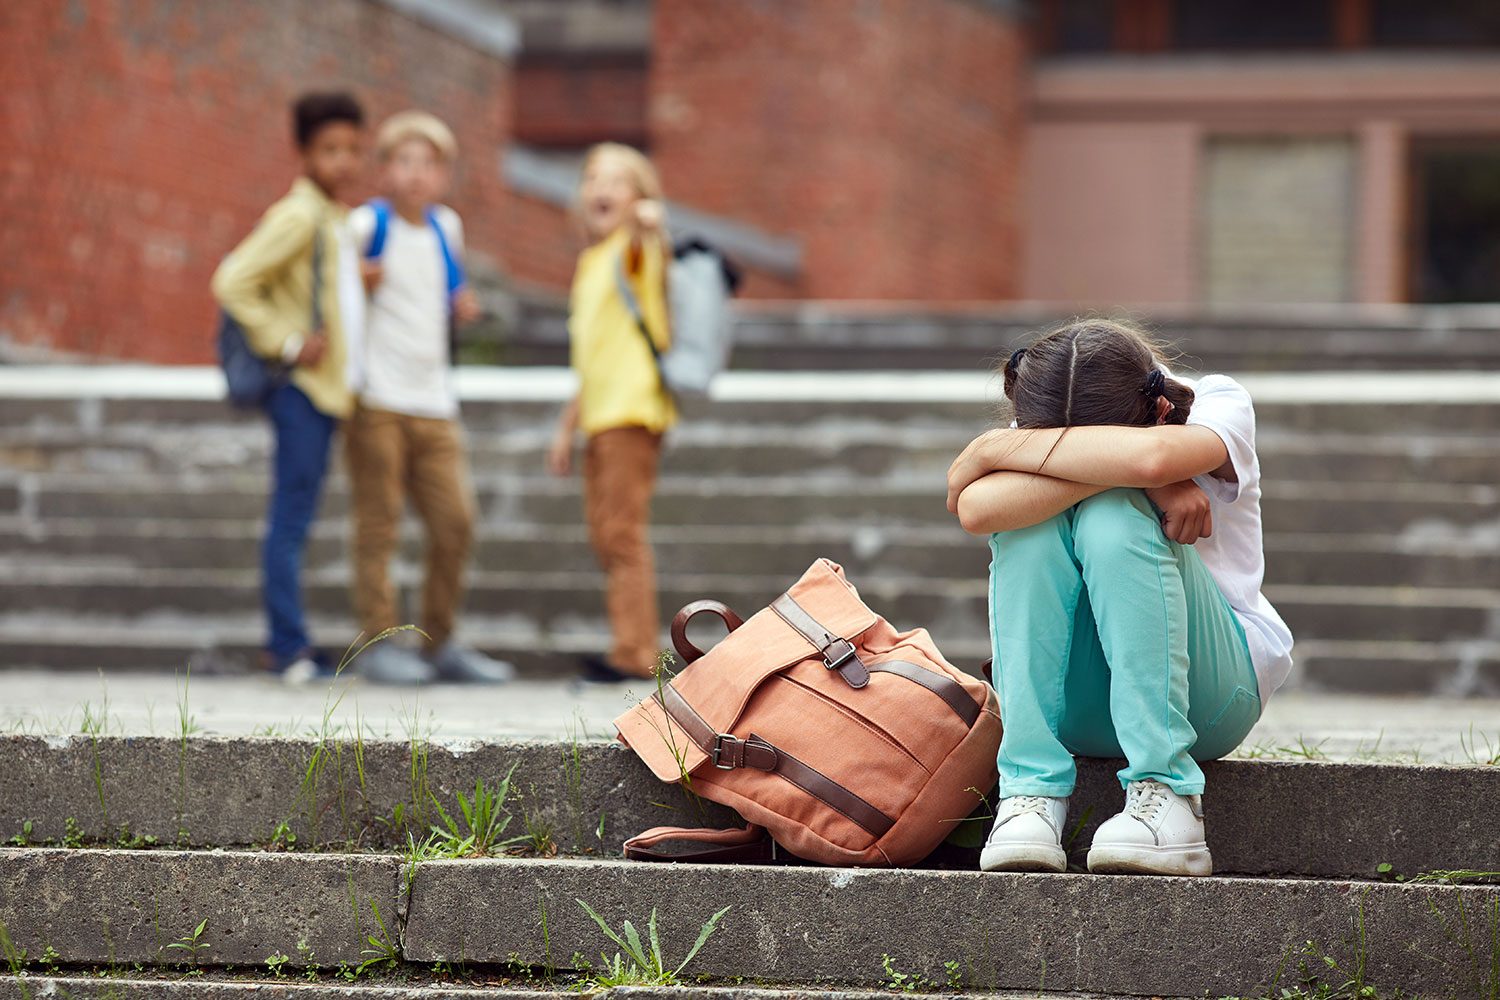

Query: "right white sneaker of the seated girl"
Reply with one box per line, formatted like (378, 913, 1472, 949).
(1089, 778, 1214, 876)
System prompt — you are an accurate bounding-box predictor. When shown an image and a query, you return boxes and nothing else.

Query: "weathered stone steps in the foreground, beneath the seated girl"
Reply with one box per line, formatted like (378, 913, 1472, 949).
(0, 733, 1500, 1000)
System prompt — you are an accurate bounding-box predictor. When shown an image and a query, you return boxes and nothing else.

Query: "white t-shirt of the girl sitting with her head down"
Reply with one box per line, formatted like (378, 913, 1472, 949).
(1178, 375, 1292, 706)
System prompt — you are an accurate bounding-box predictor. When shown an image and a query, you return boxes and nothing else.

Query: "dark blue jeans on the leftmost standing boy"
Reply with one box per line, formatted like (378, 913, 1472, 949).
(261, 384, 339, 670)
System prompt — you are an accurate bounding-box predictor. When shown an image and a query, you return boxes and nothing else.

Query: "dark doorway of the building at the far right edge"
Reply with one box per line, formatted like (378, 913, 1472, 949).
(1410, 139, 1500, 303)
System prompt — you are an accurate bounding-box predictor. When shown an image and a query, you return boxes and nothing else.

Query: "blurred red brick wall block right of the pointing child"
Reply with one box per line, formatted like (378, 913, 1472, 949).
(650, 0, 1025, 300)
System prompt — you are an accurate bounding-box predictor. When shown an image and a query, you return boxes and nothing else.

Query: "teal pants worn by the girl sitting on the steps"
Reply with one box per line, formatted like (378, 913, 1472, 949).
(990, 489, 1260, 796)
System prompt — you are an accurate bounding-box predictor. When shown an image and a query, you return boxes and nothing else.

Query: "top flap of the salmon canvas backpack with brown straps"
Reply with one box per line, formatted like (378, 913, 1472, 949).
(615, 559, 878, 781)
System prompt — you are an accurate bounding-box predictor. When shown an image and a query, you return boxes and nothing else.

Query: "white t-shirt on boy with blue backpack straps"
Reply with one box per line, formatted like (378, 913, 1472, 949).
(350, 205, 464, 418)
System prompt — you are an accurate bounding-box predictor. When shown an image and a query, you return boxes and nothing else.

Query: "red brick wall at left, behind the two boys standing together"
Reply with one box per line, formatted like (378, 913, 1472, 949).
(0, 0, 519, 361)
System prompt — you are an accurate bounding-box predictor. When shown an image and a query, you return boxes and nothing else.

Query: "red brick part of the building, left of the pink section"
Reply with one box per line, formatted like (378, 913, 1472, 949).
(0, 0, 1022, 361)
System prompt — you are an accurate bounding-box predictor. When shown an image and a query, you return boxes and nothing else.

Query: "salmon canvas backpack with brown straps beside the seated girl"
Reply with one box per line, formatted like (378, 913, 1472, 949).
(615, 559, 1001, 867)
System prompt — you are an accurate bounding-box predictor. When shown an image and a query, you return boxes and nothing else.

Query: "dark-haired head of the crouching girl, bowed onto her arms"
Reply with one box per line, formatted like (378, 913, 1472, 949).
(1001, 319, 1193, 427)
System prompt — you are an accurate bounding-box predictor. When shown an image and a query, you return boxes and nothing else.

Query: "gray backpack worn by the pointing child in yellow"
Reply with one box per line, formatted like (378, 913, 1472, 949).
(615, 237, 740, 397)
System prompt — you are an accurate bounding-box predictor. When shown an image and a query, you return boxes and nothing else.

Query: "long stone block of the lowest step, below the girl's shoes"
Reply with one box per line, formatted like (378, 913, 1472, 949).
(407, 861, 1500, 996)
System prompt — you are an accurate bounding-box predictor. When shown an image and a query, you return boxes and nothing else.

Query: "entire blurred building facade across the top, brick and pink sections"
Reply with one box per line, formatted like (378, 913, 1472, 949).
(0, 0, 1500, 361)
